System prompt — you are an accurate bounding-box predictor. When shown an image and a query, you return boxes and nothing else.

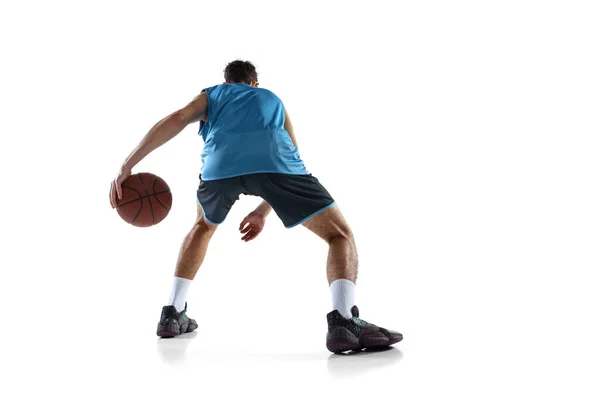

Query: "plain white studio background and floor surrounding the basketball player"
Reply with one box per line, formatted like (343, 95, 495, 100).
(0, 1, 600, 399)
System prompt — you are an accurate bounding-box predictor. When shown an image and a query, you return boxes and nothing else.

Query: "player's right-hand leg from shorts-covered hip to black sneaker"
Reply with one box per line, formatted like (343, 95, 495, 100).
(247, 174, 402, 353)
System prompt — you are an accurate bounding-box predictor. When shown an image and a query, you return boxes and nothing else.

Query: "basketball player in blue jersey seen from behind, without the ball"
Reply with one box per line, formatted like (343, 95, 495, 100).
(110, 60, 402, 353)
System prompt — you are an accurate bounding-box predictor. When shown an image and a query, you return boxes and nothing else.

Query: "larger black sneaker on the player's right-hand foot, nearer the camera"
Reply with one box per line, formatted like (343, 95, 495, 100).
(326, 306, 402, 353)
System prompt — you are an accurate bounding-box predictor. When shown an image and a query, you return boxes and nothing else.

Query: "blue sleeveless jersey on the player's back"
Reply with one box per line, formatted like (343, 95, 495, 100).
(198, 83, 308, 181)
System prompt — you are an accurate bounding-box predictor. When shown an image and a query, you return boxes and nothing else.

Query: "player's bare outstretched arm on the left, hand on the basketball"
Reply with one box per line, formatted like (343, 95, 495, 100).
(110, 92, 208, 208)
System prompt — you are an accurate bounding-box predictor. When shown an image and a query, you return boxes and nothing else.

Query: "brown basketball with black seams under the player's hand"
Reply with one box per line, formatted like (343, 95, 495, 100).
(117, 172, 173, 227)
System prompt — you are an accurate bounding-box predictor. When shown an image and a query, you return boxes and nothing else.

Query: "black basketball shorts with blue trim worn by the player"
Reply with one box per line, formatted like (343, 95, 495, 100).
(197, 173, 335, 228)
